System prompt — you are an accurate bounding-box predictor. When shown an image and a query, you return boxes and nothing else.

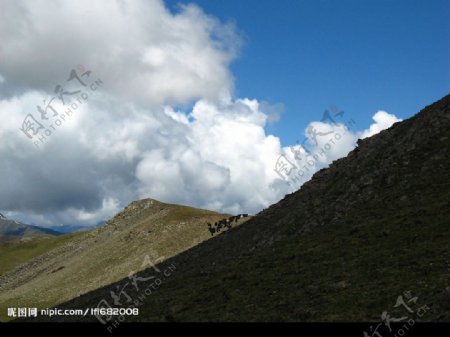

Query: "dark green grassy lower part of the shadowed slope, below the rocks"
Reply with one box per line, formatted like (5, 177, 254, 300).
(51, 189, 450, 322)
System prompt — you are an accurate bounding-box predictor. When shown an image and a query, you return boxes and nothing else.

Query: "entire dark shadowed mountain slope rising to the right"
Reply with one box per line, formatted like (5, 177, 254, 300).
(34, 96, 450, 323)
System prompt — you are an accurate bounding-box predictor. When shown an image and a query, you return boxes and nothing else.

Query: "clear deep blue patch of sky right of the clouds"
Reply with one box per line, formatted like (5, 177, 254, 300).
(167, 0, 450, 145)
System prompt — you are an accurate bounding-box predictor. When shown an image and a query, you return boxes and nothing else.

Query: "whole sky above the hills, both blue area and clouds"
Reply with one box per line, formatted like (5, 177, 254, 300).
(0, 0, 450, 227)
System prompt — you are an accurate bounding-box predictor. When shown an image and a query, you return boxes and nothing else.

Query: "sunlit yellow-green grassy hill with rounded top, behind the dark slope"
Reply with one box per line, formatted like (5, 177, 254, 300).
(0, 201, 250, 320)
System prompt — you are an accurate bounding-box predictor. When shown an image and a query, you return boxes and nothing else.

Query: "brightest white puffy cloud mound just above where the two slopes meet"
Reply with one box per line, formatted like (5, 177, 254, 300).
(137, 99, 287, 212)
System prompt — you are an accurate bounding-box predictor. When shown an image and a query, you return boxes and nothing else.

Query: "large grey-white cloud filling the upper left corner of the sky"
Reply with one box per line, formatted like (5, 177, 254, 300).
(0, 0, 240, 104)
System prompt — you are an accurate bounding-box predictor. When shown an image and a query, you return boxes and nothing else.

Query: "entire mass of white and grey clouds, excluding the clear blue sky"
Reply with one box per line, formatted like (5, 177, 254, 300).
(0, 0, 402, 226)
